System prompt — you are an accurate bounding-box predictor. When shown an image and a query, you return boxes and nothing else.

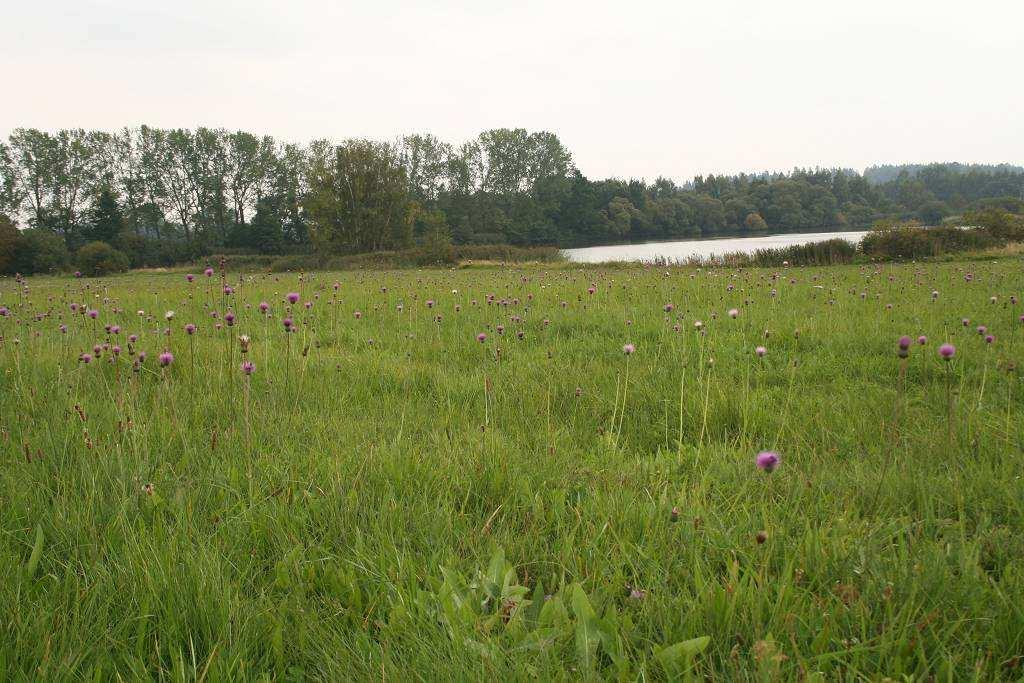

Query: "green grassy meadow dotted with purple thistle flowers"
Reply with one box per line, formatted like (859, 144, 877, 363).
(0, 255, 1024, 681)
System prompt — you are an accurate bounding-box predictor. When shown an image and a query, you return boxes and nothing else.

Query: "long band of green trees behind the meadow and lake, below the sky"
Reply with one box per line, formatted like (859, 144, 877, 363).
(0, 126, 1024, 271)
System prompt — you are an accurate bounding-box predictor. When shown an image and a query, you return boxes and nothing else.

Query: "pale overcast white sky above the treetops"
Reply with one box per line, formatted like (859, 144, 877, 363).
(0, 0, 1024, 180)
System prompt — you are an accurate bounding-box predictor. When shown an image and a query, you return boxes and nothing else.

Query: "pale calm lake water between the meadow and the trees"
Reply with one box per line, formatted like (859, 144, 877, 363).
(562, 230, 867, 263)
